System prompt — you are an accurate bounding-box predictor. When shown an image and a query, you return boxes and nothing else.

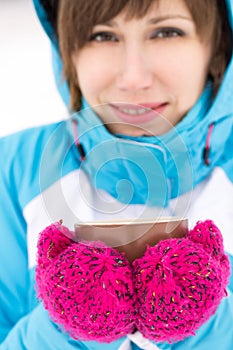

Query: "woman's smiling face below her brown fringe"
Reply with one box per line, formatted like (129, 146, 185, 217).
(73, 0, 212, 136)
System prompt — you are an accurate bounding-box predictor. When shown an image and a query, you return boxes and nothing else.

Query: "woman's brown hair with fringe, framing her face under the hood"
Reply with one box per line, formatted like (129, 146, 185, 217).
(56, 0, 232, 110)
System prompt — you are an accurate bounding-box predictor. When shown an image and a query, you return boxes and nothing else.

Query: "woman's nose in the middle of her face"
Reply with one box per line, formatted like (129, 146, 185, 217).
(117, 44, 153, 92)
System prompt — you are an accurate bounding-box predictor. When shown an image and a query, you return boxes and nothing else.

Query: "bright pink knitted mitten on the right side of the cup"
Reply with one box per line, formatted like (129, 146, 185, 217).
(133, 220, 230, 342)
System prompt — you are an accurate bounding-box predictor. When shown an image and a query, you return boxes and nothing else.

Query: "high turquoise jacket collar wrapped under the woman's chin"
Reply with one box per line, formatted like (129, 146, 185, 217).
(72, 84, 232, 208)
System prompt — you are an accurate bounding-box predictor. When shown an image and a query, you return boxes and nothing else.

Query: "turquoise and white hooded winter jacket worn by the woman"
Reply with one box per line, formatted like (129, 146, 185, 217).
(0, 0, 233, 350)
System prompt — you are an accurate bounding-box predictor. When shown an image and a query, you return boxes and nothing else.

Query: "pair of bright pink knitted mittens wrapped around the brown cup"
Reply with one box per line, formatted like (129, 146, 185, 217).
(36, 220, 230, 342)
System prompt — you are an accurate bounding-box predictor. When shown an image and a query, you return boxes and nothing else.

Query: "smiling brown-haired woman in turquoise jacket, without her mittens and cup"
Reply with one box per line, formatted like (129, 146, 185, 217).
(0, 0, 233, 350)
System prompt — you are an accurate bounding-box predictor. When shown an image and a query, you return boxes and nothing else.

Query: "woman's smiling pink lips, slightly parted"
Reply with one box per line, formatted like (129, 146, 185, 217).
(110, 103, 167, 125)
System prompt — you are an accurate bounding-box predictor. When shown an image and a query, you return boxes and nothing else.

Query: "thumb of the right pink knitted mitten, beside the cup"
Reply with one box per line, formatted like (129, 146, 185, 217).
(188, 220, 224, 260)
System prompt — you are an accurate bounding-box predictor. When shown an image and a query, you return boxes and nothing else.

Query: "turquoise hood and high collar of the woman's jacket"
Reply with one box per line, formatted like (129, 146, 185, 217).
(33, 0, 233, 208)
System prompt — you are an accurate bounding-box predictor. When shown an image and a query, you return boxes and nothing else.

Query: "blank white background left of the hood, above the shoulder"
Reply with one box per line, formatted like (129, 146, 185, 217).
(0, 0, 67, 136)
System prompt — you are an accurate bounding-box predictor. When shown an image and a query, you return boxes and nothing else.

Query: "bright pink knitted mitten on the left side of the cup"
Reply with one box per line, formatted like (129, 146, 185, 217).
(36, 223, 135, 342)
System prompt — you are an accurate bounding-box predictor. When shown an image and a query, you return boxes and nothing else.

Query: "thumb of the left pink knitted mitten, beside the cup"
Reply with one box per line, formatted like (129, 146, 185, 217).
(37, 221, 73, 268)
